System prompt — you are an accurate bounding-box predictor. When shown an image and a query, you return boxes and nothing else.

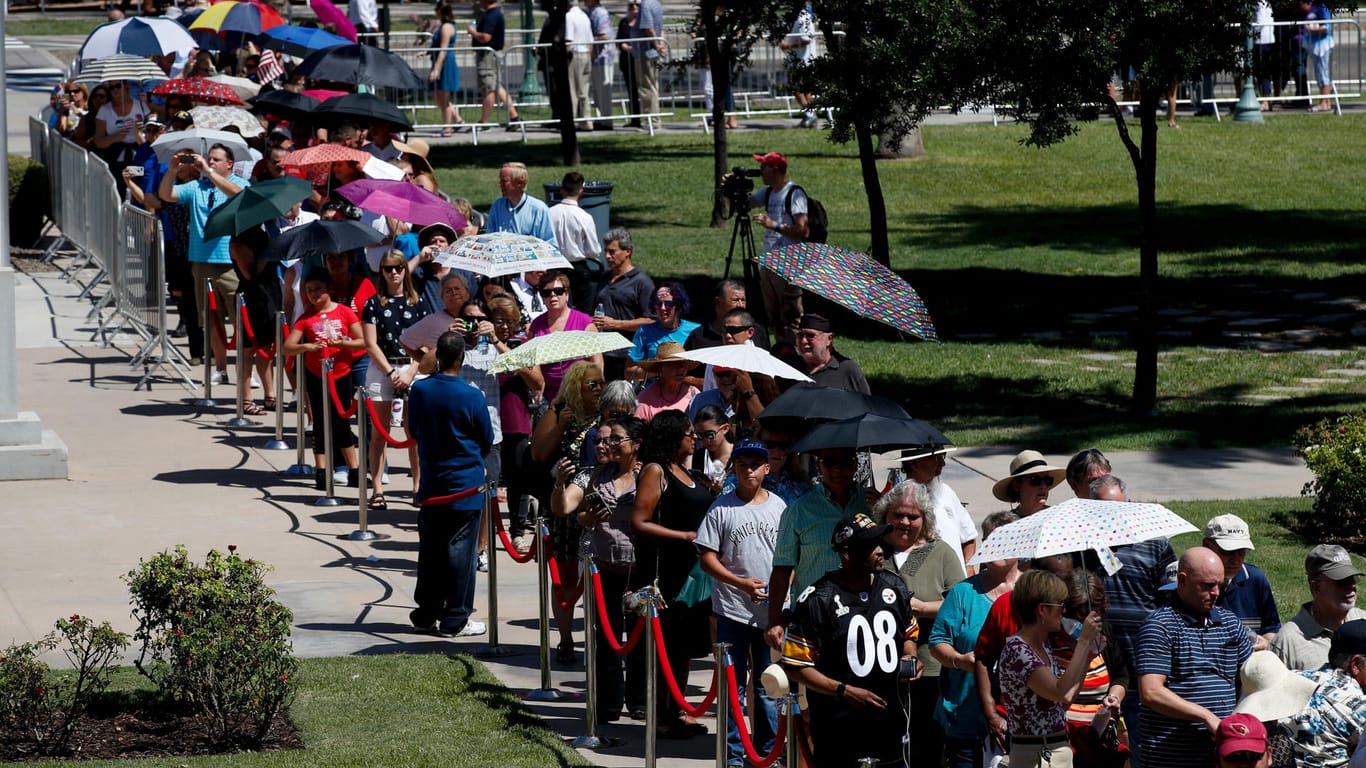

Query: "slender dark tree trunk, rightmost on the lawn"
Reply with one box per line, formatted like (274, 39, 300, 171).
(1130, 83, 1162, 417)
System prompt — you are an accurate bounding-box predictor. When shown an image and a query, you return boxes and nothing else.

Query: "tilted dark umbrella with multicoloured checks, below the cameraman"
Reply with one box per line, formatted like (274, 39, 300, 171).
(758, 243, 938, 342)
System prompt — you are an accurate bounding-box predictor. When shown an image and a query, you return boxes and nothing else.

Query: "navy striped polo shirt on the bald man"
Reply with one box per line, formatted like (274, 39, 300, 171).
(1134, 597, 1253, 768)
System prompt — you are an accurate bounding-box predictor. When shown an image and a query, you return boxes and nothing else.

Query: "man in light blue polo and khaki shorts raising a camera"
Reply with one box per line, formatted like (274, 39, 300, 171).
(157, 143, 251, 384)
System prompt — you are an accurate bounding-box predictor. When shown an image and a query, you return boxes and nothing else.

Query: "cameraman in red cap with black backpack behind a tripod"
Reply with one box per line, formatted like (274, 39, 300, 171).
(750, 152, 807, 343)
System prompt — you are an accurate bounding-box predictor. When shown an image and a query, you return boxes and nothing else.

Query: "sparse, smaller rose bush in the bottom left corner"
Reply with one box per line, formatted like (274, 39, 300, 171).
(0, 615, 128, 756)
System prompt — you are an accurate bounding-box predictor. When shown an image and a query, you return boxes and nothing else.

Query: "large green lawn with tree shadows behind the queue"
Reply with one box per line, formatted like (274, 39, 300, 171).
(433, 113, 1366, 452)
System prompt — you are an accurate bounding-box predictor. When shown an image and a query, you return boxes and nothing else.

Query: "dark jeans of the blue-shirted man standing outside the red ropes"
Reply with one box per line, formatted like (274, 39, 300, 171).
(413, 506, 482, 633)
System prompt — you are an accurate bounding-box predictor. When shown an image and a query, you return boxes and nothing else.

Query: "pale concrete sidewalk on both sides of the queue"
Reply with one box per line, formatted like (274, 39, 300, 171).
(0, 259, 1310, 765)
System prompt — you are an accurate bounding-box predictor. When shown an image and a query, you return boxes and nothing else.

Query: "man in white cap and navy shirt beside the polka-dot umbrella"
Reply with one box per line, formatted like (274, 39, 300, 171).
(1203, 515, 1280, 650)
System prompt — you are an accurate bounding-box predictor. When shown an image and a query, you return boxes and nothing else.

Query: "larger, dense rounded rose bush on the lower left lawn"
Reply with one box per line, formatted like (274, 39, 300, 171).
(126, 547, 298, 748)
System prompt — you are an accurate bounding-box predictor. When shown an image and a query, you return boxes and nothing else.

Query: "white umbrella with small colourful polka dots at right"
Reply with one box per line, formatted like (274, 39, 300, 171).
(968, 499, 1199, 574)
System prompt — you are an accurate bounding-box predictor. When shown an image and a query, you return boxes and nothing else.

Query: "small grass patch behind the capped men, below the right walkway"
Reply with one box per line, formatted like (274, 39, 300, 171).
(1167, 497, 1366, 622)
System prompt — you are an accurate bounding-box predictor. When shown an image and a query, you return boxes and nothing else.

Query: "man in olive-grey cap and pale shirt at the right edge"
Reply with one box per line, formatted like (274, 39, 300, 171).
(1272, 544, 1366, 670)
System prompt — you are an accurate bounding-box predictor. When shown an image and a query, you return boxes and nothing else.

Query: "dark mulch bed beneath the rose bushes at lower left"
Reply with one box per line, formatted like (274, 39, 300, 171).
(0, 704, 303, 763)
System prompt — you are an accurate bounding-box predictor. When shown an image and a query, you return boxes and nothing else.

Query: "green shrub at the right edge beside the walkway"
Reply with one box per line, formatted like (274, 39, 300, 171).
(1295, 411, 1366, 541)
